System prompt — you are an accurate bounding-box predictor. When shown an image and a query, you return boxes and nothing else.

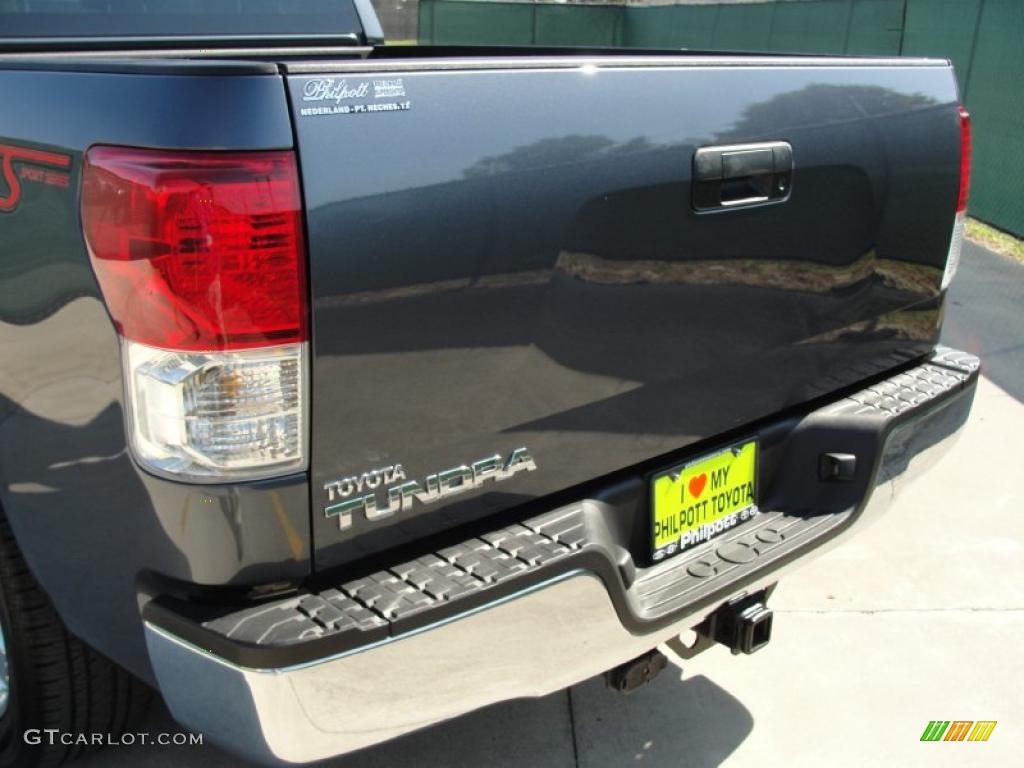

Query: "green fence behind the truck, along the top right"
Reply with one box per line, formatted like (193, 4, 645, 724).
(420, 0, 1024, 237)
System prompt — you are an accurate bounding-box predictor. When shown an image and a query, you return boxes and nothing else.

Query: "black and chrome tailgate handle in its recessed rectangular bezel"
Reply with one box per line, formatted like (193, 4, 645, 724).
(693, 141, 793, 211)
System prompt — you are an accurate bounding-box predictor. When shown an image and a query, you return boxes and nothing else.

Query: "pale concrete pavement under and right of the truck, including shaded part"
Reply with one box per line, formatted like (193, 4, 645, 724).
(82, 248, 1024, 768)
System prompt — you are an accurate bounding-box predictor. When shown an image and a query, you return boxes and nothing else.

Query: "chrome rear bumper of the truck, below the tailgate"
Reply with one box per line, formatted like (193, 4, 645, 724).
(145, 350, 978, 764)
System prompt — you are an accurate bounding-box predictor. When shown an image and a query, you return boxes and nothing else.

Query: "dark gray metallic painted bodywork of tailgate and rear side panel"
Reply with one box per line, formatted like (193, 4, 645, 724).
(0, 51, 958, 677)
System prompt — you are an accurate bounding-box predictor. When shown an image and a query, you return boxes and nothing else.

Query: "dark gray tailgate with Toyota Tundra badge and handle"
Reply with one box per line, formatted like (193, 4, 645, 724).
(288, 57, 959, 567)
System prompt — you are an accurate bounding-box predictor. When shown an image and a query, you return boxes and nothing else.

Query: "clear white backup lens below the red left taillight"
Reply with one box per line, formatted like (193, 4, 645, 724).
(124, 341, 308, 482)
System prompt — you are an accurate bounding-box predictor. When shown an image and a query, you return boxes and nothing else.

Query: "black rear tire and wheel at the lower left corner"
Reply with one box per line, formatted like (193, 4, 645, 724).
(0, 510, 152, 768)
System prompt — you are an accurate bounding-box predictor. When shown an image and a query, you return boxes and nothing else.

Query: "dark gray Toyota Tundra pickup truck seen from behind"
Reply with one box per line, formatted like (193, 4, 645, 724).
(0, 0, 978, 766)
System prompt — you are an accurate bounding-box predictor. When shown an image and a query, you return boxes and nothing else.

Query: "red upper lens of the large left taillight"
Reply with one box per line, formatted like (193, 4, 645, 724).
(82, 146, 308, 350)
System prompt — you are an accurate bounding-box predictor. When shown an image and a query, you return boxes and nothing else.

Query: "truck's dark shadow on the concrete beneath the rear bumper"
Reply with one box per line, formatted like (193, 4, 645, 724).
(80, 666, 754, 768)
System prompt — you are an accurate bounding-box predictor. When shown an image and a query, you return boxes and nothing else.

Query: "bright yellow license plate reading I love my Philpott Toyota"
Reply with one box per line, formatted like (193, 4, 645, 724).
(651, 440, 758, 560)
